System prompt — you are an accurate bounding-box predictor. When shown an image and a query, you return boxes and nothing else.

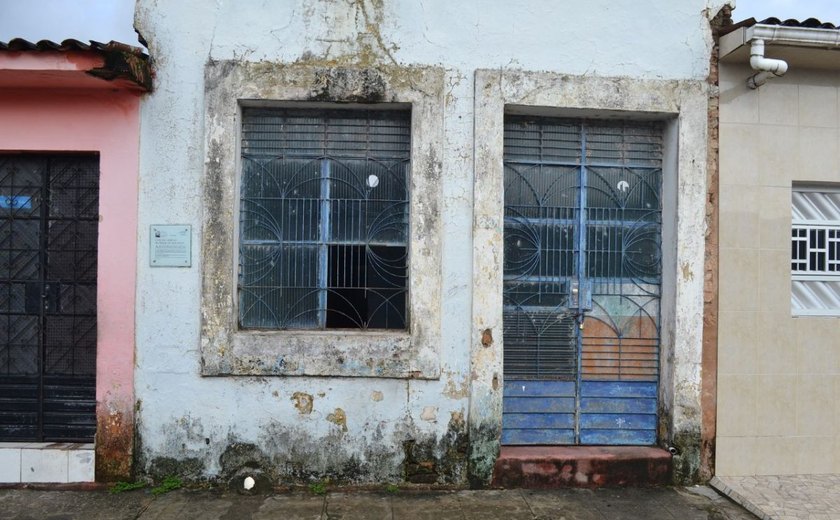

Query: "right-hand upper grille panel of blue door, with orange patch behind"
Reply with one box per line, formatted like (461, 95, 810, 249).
(580, 122, 663, 383)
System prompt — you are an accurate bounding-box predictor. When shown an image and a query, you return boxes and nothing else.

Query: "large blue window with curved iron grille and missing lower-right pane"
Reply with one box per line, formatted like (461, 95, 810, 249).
(239, 108, 411, 330)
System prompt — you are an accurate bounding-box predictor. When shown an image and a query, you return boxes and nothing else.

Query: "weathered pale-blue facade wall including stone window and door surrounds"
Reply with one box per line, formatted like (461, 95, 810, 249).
(135, 0, 710, 486)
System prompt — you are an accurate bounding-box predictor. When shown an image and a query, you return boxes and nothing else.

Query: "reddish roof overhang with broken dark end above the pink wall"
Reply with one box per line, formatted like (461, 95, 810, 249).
(0, 39, 152, 92)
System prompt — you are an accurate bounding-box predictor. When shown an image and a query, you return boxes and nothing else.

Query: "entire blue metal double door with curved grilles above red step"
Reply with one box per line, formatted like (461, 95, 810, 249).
(502, 116, 662, 445)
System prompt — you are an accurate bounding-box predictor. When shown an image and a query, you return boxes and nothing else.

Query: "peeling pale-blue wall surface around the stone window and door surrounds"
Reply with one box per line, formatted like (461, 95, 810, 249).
(135, 0, 723, 481)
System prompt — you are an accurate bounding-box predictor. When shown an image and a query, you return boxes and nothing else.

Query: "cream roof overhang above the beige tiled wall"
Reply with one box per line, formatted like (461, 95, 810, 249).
(719, 23, 840, 70)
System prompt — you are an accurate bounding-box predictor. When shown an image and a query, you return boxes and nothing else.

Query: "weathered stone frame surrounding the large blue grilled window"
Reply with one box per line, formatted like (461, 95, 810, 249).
(200, 61, 445, 379)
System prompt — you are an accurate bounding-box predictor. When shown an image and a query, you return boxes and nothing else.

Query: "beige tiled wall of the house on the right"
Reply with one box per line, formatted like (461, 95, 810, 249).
(716, 64, 840, 476)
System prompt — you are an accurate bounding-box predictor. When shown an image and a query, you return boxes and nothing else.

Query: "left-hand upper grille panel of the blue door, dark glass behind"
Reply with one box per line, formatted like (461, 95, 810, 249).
(504, 117, 581, 380)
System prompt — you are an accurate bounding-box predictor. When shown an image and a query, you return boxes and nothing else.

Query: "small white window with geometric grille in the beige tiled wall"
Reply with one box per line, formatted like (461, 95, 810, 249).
(790, 187, 840, 315)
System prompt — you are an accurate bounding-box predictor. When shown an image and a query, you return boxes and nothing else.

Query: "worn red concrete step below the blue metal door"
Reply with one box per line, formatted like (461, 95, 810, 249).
(493, 446, 672, 489)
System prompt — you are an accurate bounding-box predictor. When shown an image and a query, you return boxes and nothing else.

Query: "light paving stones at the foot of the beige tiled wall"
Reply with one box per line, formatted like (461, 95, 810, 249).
(712, 474, 840, 520)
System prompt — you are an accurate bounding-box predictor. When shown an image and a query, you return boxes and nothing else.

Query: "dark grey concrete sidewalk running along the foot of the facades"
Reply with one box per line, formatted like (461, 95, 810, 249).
(0, 487, 755, 520)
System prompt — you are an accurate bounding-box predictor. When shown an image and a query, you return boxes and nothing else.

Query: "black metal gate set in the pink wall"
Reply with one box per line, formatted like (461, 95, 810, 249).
(0, 154, 98, 442)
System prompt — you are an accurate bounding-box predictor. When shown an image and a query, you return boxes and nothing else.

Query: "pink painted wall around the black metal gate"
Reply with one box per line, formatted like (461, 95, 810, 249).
(0, 86, 140, 472)
